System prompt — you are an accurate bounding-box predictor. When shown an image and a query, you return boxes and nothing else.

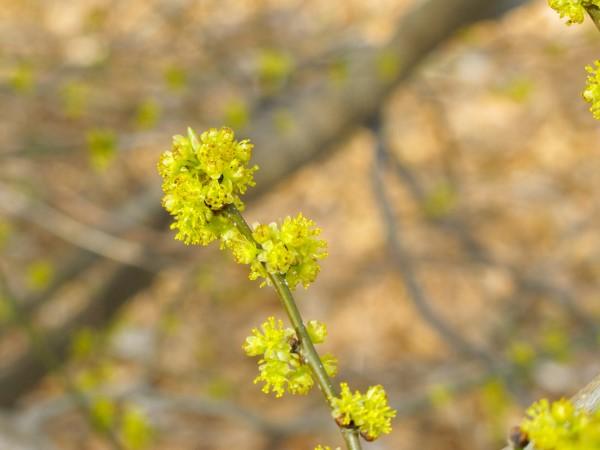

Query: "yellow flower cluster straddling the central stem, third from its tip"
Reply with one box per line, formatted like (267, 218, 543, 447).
(242, 317, 337, 397)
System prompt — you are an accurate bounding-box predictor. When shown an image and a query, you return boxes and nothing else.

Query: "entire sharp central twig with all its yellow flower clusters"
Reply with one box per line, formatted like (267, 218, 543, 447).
(158, 128, 396, 449)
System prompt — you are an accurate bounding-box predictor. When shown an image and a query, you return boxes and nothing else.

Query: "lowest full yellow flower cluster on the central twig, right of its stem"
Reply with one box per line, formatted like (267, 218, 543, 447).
(332, 383, 396, 441)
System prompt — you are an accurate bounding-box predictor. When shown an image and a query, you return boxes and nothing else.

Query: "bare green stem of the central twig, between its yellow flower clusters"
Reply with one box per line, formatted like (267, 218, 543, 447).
(222, 205, 361, 450)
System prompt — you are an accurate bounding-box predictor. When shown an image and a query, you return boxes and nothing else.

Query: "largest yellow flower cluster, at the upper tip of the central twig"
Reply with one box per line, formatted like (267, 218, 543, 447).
(158, 127, 258, 245)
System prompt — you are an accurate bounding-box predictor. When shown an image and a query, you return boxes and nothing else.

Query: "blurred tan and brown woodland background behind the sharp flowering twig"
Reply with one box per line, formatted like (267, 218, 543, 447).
(0, 0, 600, 450)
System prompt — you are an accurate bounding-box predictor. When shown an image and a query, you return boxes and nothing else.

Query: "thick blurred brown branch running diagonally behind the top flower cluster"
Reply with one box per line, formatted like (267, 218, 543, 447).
(0, 0, 520, 406)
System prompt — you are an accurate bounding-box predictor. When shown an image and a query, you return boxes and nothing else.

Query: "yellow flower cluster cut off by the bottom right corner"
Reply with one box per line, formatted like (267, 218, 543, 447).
(521, 399, 600, 450)
